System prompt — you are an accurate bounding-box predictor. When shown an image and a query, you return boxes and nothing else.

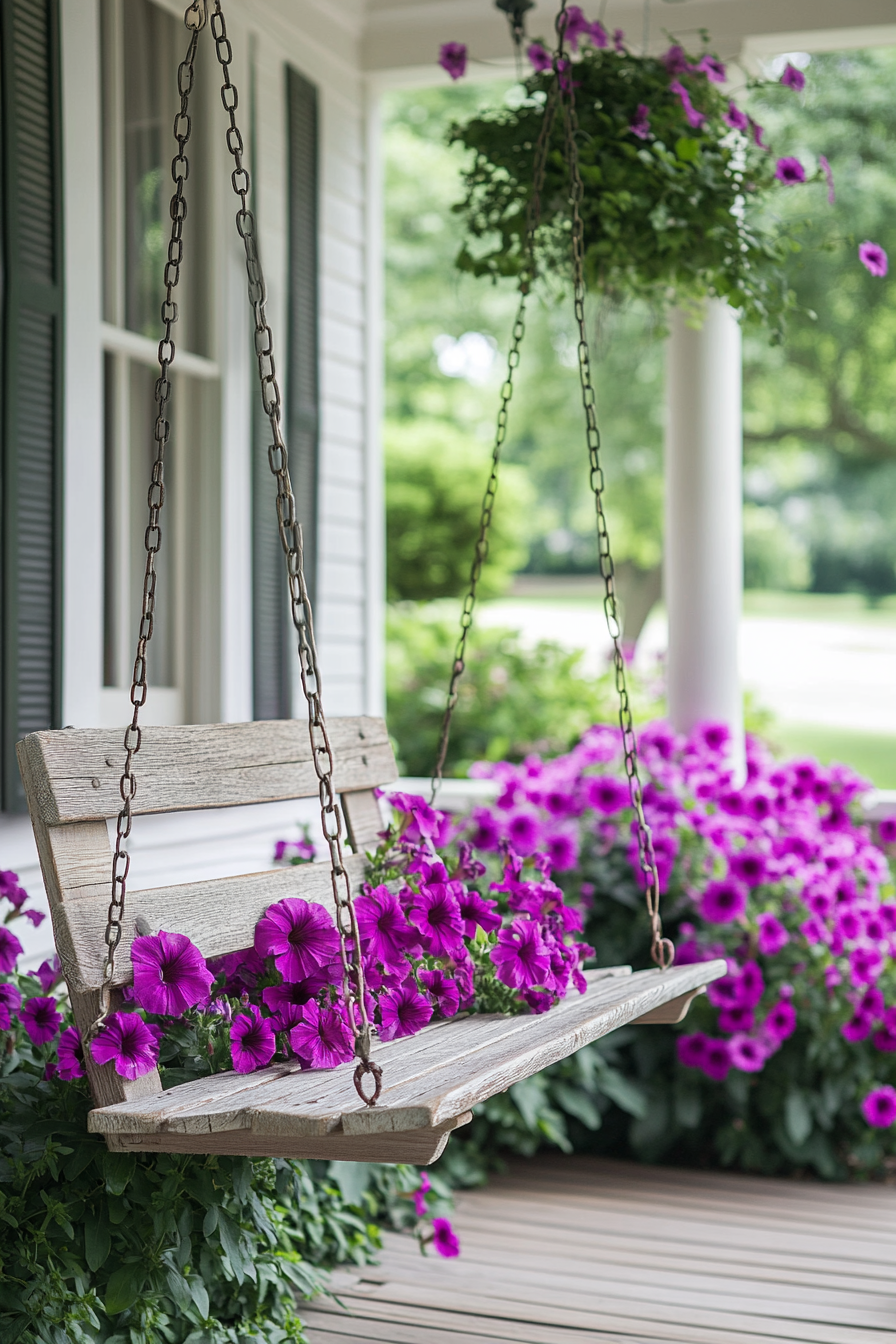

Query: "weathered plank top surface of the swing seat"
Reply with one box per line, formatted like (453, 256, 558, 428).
(90, 961, 727, 1138)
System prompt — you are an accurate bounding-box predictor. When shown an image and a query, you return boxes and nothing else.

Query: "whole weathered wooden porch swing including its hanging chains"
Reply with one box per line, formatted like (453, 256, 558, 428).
(17, 0, 725, 1164)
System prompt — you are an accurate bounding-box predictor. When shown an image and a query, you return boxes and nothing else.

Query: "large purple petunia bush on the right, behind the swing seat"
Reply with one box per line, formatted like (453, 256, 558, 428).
(435, 724, 896, 1180)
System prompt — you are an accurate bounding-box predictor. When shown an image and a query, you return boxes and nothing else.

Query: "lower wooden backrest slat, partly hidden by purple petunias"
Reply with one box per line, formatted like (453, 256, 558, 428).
(54, 854, 367, 989)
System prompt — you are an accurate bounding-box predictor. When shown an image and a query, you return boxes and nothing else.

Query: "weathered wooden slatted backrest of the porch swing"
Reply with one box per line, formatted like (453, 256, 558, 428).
(17, 718, 398, 1102)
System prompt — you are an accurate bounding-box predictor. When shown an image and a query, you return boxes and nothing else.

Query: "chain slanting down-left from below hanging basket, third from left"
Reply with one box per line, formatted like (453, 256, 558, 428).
(430, 83, 557, 804)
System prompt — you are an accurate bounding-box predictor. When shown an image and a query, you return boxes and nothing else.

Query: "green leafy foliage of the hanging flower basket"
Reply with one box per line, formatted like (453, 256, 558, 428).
(453, 46, 797, 331)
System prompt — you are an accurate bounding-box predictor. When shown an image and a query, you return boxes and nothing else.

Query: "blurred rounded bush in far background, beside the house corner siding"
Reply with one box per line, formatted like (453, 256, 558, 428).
(386, 419, 533, 601)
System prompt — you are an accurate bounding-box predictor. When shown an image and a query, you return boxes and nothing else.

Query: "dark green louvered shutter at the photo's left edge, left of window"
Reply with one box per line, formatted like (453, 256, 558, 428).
(0, 0, 63, 810)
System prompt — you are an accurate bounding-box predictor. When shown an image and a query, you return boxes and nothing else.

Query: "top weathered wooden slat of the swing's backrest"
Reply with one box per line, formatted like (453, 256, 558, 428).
(19, 718, 398, 825)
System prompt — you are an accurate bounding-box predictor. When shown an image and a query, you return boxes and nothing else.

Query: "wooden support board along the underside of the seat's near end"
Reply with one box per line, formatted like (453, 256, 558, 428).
(106, 1111, 473, 1167)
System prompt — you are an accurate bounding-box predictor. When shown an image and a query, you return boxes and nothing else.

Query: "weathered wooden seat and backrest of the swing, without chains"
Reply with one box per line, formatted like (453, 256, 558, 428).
(17, 718, 727, 1165)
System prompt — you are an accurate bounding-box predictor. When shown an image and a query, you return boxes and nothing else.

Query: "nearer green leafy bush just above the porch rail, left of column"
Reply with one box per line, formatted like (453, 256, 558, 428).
(386, 605, 658, 775)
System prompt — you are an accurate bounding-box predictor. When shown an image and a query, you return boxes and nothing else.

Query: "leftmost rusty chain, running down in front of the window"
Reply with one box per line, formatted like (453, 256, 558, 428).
(90, 4, 206, 1036)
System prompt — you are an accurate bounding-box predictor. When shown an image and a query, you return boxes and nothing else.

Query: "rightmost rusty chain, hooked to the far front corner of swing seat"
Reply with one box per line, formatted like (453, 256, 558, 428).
(555, 0, 676, 970)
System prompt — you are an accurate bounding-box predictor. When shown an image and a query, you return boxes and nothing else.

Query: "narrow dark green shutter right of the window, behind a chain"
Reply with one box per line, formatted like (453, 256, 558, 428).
(253, 67, 318, 719)
